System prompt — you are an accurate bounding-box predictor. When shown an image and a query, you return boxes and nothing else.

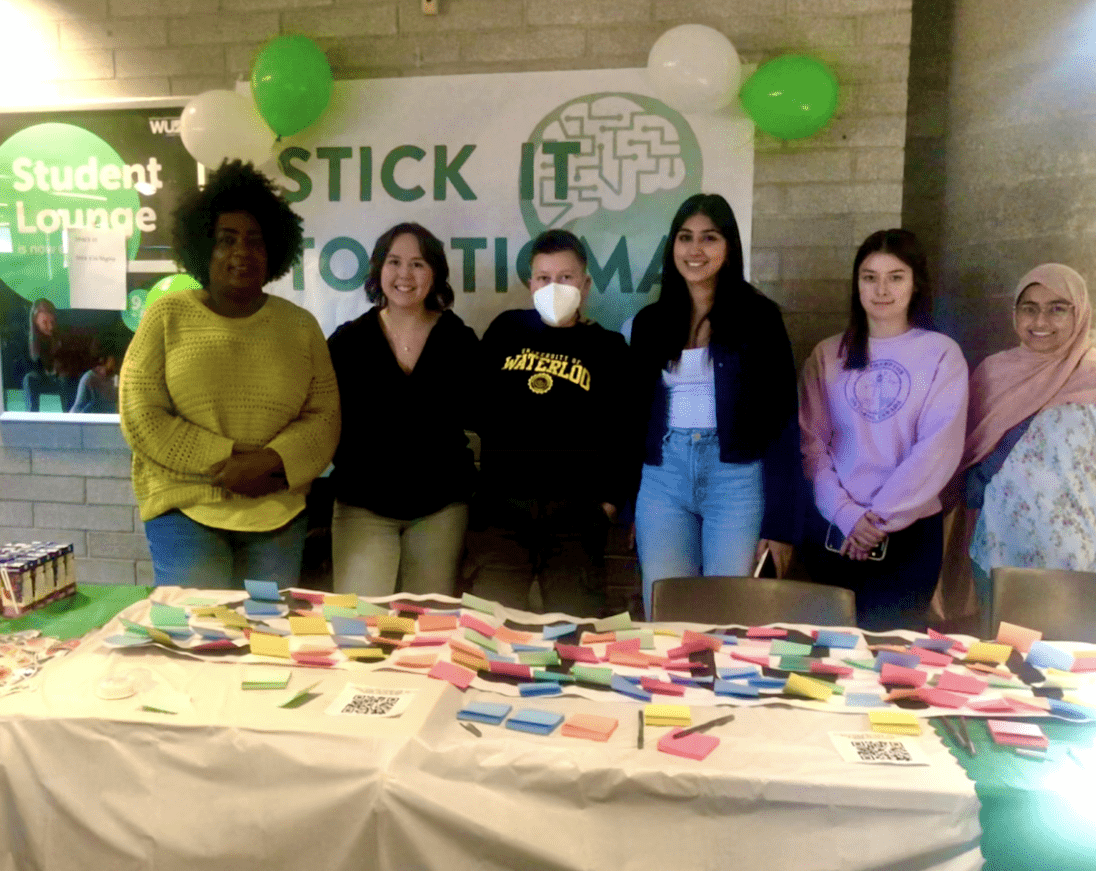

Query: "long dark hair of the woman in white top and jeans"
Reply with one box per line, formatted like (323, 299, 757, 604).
(654, 194, 757, 364)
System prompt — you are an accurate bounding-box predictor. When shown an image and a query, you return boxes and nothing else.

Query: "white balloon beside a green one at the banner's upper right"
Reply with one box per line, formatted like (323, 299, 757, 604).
(647, 24, 742, 112)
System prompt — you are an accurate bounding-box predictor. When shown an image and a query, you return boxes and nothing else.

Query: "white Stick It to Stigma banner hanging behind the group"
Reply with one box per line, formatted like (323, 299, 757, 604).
(257, 69, 753, 334)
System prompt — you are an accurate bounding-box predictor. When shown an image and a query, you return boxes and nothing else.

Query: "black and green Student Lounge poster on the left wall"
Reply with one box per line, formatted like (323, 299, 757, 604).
(0, 99, 198, 413)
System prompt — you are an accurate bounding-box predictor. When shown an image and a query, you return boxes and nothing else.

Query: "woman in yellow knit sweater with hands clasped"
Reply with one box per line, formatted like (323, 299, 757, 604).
(118, 161, 340, 587)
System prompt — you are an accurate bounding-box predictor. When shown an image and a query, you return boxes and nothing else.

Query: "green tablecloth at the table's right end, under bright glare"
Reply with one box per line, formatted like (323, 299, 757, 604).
(932, 718, 1096, 871)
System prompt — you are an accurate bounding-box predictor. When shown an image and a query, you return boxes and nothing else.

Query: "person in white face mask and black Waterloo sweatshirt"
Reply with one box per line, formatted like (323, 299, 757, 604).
(468, 230, 633, 616)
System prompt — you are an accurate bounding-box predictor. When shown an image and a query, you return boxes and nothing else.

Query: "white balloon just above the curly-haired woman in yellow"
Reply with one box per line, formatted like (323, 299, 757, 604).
(179, 91, 274, 169)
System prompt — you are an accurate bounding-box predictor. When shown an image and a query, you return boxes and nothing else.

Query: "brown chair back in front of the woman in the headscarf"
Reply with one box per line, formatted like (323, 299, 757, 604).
(989, 568, 1096, 642)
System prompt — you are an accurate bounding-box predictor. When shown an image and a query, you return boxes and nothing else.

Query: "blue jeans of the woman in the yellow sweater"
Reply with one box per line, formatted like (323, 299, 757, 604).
(145, 511, 308, 589)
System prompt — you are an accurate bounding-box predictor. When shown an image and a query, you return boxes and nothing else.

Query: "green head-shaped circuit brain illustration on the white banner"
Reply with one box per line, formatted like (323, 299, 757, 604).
(521, 93, 704, 329)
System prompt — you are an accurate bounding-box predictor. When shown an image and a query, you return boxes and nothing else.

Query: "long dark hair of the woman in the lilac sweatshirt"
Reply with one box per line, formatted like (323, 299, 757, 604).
(838, 228, 936, 369)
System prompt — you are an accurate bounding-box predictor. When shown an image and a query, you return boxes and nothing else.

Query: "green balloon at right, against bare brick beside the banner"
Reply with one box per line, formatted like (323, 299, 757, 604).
(739, 55, 838, 139)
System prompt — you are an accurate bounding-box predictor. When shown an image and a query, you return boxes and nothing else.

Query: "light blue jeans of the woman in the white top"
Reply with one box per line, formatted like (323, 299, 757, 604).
(636, 428, 765, 618)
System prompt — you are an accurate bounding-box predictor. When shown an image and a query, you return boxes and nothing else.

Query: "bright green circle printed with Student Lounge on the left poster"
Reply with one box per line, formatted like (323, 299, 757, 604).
(0, 123, 145, 308)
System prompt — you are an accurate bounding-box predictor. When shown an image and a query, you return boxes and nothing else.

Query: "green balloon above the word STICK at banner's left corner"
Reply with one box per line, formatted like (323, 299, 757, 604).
(251, 36, 332, 136)
